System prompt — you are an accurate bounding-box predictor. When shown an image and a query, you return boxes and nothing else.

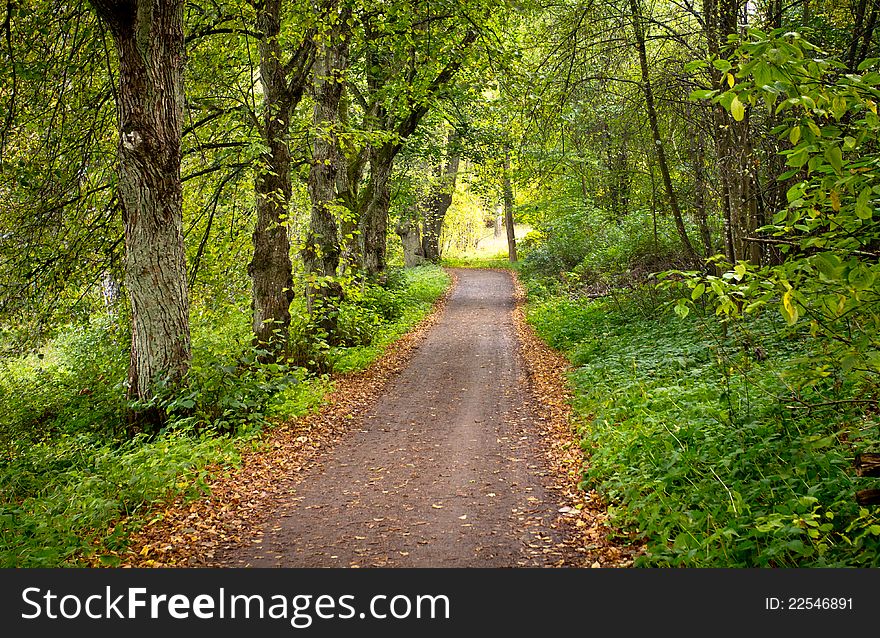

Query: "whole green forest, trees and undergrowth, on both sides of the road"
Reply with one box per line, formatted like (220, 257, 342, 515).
(0, 0, 880, 567)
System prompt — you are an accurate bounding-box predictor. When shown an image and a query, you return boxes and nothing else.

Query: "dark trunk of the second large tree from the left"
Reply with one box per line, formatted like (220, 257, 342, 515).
(248, 0, 293, 352)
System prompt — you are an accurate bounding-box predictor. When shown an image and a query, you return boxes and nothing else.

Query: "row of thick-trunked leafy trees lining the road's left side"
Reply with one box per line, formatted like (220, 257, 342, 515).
(0, 0, 505, 430)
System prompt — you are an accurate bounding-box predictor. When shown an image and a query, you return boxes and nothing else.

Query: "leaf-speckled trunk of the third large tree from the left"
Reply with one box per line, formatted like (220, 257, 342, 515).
(303, 17, 348, 337)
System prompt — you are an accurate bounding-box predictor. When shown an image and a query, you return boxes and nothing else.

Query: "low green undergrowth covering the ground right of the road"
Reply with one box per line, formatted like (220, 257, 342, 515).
(530, 298, 880, 567)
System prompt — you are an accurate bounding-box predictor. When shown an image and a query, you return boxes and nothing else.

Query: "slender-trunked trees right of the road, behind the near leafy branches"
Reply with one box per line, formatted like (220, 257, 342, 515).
(522, 0, 878, 263)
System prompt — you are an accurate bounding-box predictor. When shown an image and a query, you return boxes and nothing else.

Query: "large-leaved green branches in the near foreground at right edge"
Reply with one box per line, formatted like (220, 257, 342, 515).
(678, 30, 880, 393)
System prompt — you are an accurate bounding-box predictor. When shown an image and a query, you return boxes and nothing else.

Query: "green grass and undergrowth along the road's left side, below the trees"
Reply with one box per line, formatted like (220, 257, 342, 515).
(0, 266, 449, 567)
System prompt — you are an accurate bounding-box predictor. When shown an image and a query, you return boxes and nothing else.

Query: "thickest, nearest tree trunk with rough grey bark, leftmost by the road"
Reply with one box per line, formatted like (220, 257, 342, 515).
(92, 0, 190, 418)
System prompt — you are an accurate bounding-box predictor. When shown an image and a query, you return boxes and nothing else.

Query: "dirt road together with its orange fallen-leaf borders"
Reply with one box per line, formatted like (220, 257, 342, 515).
(120, 269, 634, 567)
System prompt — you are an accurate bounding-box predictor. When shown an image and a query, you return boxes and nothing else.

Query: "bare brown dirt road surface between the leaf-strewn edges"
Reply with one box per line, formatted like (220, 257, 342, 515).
(222, 269, 574, 567)
